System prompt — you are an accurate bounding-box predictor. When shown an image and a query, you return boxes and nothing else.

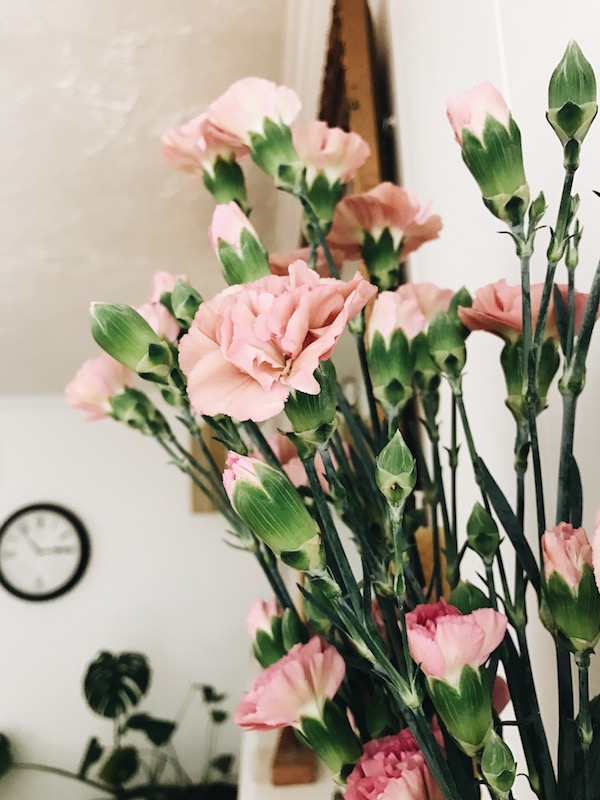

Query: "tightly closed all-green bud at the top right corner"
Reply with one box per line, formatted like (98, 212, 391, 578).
(546, 41, 598, 149)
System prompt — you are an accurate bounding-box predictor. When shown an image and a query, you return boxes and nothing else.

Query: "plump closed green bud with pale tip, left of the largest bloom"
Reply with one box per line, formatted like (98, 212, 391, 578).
(90, 303, 162, 372)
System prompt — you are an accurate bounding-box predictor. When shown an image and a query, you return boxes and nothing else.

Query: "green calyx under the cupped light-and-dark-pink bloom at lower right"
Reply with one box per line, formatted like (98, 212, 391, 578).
(427, 666, 493, 757)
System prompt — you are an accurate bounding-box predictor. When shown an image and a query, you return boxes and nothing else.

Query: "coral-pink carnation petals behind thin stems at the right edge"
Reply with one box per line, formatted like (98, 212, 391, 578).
(458, 278, 587, 341)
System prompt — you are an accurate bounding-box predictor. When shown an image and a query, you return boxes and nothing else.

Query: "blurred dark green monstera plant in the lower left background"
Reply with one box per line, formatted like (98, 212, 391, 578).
(0, 651, 237, 800)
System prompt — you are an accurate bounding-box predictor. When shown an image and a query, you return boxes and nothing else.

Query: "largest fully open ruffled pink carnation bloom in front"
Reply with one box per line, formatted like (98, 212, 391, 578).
(179, 261, 377, 422)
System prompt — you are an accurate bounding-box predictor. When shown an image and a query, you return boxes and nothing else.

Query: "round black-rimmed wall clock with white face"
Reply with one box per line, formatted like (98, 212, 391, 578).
(0, 503, 90, 601)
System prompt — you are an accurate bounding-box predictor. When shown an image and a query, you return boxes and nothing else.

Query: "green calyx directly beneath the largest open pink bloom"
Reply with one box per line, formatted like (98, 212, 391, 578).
(285, 361, 337, 447)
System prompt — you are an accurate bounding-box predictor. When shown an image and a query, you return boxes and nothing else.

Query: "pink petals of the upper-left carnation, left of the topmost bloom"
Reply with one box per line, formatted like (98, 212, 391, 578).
(160, 114, 248, 174)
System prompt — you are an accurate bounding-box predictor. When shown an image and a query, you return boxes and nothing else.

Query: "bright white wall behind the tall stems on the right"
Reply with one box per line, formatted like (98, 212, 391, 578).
(378, 0, 600, 798)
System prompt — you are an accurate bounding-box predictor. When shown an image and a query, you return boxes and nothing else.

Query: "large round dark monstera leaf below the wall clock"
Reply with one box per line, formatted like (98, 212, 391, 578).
(83, 652, 150, 719)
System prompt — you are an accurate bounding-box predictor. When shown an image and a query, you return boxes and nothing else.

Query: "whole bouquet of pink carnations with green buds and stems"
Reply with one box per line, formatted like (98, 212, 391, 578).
(67, 43, 600, 800)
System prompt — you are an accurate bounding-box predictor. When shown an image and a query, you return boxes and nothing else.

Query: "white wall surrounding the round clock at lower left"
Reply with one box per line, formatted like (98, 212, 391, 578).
(0, 397, 271, 800)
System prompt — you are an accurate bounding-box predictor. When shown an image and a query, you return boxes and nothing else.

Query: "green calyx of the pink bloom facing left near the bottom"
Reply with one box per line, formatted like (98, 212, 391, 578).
(300, 700, 362, 781)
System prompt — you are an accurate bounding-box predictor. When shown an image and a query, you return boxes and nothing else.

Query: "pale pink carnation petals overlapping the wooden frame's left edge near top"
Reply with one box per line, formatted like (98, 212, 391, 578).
(292, 119, 371, 186)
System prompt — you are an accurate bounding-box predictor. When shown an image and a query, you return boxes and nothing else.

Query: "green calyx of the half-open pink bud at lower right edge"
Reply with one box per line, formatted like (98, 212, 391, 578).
(545, 564, 600, 653)
